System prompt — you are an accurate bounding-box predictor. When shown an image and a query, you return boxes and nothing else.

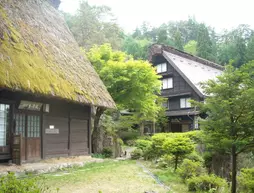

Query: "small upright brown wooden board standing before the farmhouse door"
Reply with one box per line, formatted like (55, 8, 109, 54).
(12, 134, 22, 165)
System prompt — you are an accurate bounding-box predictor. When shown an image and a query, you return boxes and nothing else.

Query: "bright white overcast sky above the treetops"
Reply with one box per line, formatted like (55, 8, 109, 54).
(60, 0, 254, 32)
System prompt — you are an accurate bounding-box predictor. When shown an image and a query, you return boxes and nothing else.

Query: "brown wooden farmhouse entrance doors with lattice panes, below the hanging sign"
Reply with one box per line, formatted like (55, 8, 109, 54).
(15, 112, 41, 161)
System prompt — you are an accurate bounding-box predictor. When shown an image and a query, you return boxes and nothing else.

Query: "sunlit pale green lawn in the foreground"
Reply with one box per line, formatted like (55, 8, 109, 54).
(39, 161, 167, 193)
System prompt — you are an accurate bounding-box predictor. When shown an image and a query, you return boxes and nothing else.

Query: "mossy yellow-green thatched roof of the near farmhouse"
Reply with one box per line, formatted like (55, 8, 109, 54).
(0, 0, 115, 108)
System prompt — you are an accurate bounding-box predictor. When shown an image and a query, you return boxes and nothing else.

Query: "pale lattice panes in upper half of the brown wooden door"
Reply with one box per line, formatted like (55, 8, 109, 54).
(27, 115, 41, 137)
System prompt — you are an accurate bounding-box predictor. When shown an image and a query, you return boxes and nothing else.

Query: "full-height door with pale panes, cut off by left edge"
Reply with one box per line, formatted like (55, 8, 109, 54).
(0, 104, 11, 160)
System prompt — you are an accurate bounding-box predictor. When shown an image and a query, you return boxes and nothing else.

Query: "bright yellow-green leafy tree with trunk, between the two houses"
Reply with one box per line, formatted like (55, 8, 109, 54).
(87, 44, 161, 152)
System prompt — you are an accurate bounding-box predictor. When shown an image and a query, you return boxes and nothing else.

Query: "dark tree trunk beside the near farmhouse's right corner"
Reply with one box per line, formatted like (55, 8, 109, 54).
(92, 107, 106, 153)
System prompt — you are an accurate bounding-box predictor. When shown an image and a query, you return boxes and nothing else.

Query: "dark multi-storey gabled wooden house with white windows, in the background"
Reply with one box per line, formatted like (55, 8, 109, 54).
(149, 44, 223, 132)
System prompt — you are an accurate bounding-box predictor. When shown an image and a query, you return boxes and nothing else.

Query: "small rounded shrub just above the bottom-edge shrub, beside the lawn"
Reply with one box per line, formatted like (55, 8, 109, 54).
(178, 159, 205, 181)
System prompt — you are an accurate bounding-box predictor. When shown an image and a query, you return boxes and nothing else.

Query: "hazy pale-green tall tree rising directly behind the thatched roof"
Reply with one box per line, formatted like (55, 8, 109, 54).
(64, 1, 123, 49)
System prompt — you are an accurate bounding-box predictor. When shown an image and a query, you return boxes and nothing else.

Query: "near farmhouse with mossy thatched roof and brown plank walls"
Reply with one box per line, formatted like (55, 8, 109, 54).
(0, 0, 115, 161)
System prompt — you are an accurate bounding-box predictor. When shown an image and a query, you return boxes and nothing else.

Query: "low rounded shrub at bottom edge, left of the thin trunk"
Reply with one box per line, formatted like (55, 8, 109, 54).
(187, 175, 227, 193)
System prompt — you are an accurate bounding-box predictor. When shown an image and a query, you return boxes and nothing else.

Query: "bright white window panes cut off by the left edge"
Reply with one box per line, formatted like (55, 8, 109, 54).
(0, 104, 10, 146)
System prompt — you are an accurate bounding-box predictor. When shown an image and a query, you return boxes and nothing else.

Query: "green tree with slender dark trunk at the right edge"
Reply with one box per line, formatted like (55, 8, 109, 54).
(197, 62, 254, 193)
